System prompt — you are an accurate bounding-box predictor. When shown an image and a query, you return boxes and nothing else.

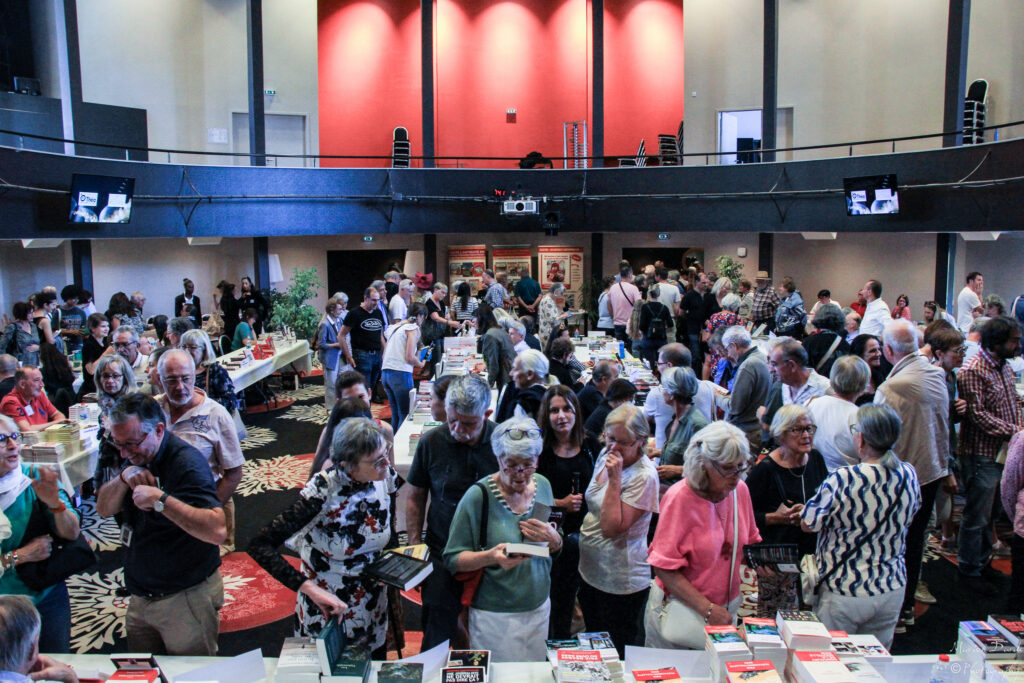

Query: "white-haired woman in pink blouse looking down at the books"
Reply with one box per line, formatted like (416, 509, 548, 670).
(644, 421, 761, 649)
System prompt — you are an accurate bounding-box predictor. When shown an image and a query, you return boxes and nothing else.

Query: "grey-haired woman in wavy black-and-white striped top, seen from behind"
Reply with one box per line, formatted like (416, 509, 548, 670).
(801, 404, 921, 647)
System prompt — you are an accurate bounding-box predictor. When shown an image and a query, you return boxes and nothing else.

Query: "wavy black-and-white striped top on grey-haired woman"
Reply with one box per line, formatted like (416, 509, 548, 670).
(803, 461, 921, 597)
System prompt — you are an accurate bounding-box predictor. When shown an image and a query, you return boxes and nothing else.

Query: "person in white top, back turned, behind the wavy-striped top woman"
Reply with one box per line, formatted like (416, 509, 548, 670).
(807, 355, 871, 472)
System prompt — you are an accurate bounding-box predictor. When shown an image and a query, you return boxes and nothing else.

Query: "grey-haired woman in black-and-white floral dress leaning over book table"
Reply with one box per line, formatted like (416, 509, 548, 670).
(249, 418, 398, 659)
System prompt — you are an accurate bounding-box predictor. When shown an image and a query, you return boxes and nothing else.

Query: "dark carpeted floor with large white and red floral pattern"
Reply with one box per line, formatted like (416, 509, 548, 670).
(68, 370, 1010, 657)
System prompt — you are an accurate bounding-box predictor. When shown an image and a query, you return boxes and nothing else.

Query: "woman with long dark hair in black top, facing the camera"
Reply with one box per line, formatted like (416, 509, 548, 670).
(537, 384, 600, 639)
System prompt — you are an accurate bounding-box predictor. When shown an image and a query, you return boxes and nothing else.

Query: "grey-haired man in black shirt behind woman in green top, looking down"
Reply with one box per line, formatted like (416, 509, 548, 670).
(406, 375, 498, 650)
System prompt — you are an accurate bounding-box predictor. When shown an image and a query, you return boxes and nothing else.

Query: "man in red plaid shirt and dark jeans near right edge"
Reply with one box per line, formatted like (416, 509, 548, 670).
(956, 316, 1024, 596)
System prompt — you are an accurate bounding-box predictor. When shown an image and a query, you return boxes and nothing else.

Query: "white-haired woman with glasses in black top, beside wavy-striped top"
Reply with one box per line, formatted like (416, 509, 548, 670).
(746, 405, 831, 616)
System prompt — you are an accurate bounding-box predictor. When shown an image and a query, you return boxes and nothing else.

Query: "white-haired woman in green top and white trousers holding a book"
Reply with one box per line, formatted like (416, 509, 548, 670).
(444, 418, 562, 661)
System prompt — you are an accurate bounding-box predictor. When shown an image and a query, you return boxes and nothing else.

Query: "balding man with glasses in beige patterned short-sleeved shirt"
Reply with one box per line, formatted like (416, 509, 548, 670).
(157, 349, 246, 556)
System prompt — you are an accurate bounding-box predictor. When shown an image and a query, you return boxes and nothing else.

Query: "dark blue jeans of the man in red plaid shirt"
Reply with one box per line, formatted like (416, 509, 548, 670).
(957, 454, 1002, 577)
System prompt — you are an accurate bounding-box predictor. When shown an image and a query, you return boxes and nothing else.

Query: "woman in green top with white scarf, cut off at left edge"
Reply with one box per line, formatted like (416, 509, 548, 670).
(0, 416, 80, 652)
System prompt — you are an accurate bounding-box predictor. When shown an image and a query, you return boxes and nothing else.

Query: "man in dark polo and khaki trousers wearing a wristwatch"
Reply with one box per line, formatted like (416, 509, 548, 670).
(96, 393, 226, 655)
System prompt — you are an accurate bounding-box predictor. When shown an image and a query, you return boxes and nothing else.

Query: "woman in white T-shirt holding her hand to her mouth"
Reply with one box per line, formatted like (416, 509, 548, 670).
(580, 403, 659, 656)
